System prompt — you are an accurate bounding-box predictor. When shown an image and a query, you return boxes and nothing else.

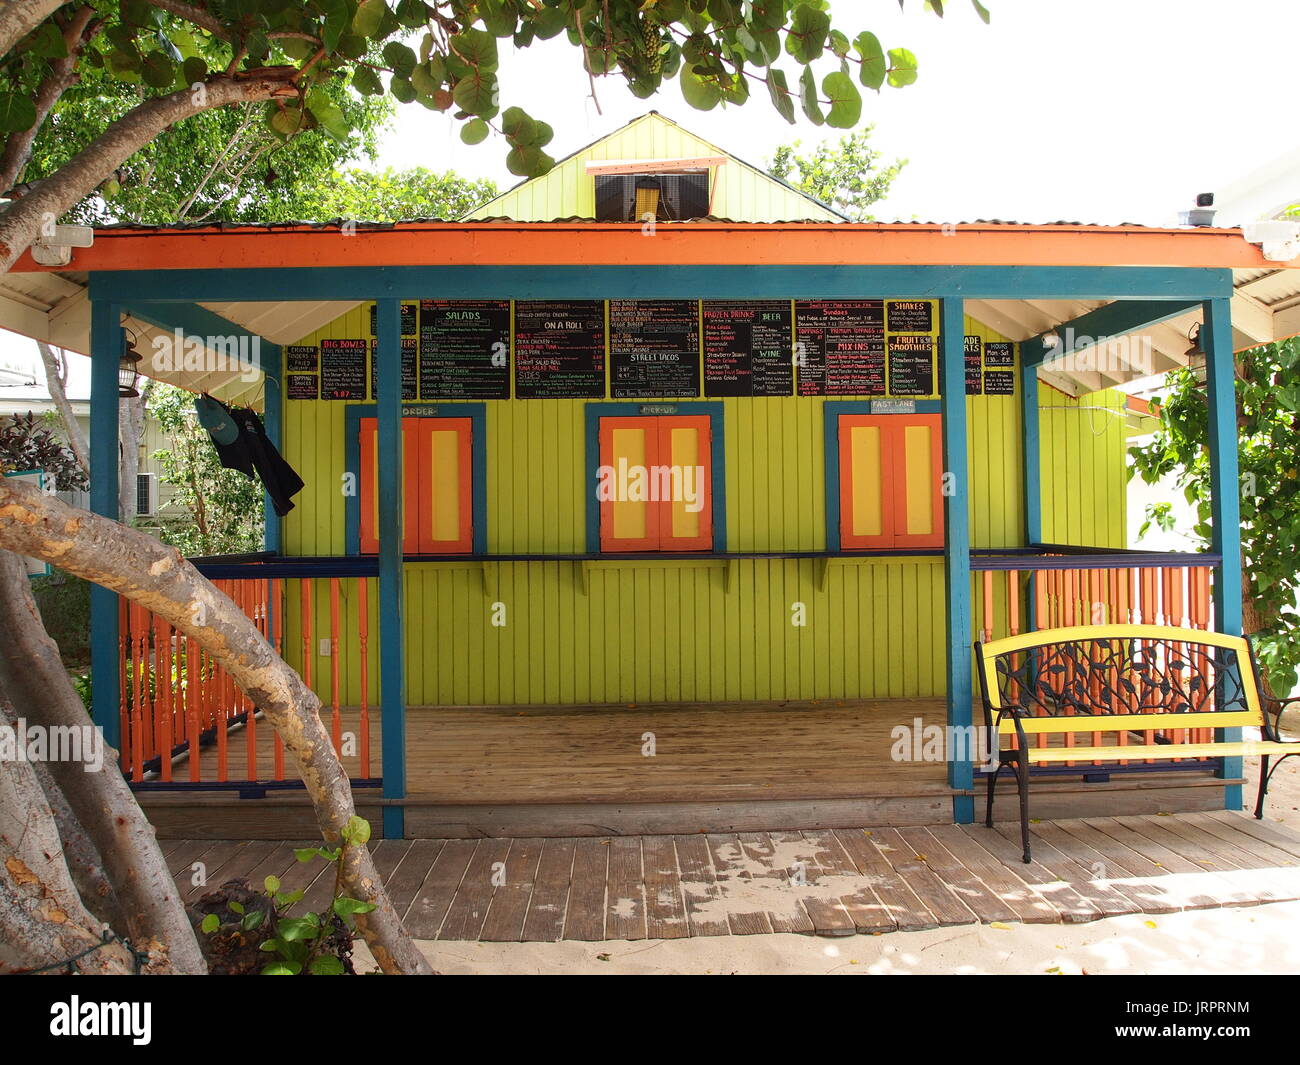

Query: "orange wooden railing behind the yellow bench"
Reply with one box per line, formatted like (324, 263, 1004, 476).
(972, 555, 1213, 767)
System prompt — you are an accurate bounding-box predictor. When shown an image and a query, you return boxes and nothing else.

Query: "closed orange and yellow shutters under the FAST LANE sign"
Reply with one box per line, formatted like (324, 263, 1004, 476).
(839, 415, 944, 550)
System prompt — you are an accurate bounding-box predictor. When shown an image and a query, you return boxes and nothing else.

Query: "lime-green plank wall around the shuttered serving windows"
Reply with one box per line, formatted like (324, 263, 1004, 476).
(276, 307, 1125, 705)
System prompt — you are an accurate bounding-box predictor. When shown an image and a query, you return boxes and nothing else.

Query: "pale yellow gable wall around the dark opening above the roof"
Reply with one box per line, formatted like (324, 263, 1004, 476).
(465, 113, 842, 222)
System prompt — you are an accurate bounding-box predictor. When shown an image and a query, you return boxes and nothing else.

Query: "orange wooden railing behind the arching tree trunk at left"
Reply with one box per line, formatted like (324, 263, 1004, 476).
(118, 577, 374, 785)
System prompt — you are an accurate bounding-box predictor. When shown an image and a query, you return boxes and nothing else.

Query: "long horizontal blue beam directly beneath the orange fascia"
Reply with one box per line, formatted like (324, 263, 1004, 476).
(88, 264, 1232, 303)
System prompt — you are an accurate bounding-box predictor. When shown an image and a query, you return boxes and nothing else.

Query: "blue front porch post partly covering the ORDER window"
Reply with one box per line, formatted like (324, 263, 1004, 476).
(374, 299, 406, 839)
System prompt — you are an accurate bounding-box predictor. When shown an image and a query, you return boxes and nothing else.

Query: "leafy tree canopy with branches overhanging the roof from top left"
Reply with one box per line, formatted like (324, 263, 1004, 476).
(0, 0, 988, 270)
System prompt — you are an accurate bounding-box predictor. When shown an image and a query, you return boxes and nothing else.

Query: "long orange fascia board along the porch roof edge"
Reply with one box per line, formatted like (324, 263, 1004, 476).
(14, 221, 1300, 272)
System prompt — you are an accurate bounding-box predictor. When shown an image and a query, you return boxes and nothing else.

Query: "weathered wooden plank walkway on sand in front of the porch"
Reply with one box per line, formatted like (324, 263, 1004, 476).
(164, 813, 1300, 943)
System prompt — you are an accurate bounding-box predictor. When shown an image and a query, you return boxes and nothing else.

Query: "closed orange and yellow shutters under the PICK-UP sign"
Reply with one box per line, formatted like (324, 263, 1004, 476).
(598, 415, 714, 551)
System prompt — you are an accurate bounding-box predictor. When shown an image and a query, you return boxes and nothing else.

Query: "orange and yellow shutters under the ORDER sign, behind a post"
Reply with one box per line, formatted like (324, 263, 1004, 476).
(360, 417, 473, 555)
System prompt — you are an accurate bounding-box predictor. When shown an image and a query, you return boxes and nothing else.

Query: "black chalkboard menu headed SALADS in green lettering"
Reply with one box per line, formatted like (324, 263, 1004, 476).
(420, 299, 510, 399)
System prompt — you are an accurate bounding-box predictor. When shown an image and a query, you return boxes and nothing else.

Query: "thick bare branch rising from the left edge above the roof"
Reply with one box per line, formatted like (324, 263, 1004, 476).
(0, 72, 298, 273)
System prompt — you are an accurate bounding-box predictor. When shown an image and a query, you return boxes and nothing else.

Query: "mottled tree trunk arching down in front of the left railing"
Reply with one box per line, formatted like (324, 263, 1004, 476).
(0, 480, 433, 973)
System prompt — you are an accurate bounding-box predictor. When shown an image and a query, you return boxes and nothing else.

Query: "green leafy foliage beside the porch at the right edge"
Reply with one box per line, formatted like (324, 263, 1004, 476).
(1128, 338, 1300, 694)
